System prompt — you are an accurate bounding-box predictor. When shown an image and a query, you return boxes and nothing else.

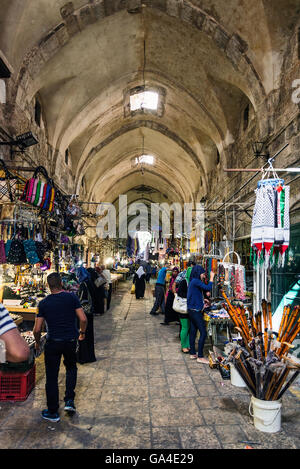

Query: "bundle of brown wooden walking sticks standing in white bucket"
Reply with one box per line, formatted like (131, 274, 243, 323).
(222, 292, 300, 401)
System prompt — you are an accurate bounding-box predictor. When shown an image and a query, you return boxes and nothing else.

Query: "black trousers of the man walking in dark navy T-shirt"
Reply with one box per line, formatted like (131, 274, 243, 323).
(45, 340, 77, 413)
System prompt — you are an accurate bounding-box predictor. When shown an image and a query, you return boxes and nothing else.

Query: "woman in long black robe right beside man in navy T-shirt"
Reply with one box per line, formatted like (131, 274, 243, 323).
(77, 267, 96, 364)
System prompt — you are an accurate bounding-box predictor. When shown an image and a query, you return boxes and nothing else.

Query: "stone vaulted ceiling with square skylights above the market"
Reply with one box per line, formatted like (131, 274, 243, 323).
(0, 0, 299, 208)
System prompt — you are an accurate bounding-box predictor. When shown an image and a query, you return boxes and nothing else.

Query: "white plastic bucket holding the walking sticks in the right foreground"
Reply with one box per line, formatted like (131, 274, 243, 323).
(249, 396, 282, 433)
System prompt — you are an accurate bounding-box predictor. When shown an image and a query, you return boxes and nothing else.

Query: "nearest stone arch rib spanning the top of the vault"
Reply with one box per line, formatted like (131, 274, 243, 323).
(15, 0, 266, 112)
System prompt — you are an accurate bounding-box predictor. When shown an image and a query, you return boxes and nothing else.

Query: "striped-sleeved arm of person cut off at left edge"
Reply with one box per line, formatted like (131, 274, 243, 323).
(0, 303, 30, 363)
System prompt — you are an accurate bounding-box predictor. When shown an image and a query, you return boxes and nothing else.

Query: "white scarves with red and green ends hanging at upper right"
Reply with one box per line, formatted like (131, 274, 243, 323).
(251, 161, 290, 269)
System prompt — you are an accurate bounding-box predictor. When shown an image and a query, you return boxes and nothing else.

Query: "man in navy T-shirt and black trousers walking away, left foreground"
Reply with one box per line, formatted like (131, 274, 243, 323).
(33, 273, 87, 422)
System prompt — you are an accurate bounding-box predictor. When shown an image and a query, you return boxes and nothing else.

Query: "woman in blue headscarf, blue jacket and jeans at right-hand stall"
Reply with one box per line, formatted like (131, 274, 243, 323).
(187, 265, 215, 364)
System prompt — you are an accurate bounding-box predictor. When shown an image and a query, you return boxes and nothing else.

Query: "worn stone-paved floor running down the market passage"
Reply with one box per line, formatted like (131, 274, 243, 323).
(0, 283, 300, 449)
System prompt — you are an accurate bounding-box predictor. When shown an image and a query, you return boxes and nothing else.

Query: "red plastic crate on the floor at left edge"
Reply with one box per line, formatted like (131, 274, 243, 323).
(0, 365, 35, 401)
